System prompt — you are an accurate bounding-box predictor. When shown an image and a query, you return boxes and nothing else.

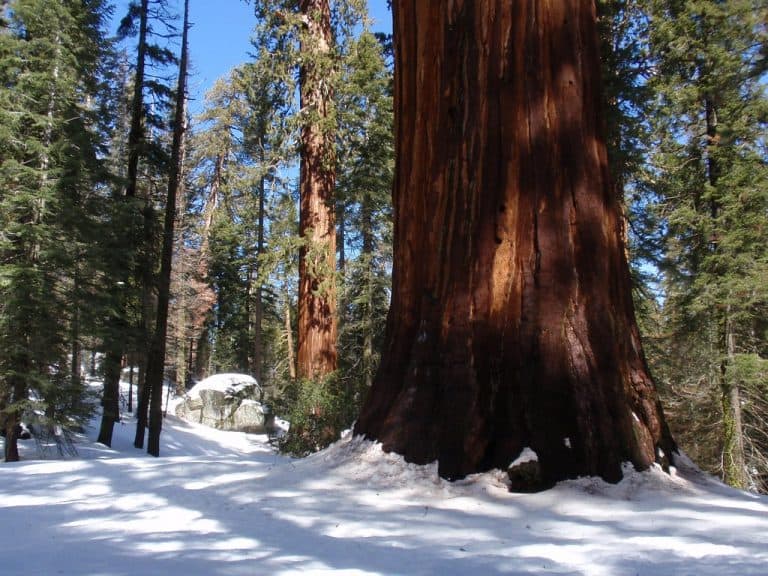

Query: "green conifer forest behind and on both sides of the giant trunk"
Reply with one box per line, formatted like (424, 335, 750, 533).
(0, 0, 768, 492)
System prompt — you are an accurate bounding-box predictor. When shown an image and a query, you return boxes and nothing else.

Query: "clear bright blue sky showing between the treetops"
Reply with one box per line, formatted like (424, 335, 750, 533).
(115, 0, 392, 113)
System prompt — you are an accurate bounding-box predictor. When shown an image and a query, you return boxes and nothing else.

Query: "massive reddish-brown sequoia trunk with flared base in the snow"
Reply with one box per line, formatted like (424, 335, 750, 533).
(356, 0, 674, 484)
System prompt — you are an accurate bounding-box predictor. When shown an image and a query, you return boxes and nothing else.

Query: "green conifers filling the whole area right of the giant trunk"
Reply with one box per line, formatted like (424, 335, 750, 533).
(598, 0, 768, 491)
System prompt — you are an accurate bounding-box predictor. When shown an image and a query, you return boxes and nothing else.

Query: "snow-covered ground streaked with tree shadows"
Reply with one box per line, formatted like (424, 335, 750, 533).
(0, 380, 768, 576)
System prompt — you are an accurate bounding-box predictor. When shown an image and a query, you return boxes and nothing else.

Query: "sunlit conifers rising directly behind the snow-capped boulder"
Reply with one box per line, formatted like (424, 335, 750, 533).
(184, 61, 291, 388)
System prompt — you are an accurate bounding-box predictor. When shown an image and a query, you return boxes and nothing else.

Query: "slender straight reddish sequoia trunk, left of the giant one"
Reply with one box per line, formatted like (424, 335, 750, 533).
(297, 0, 338, 379)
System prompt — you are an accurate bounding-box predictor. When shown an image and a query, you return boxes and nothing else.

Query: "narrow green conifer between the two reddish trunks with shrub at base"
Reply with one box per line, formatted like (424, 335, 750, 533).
(277, 31, 394, 455)
